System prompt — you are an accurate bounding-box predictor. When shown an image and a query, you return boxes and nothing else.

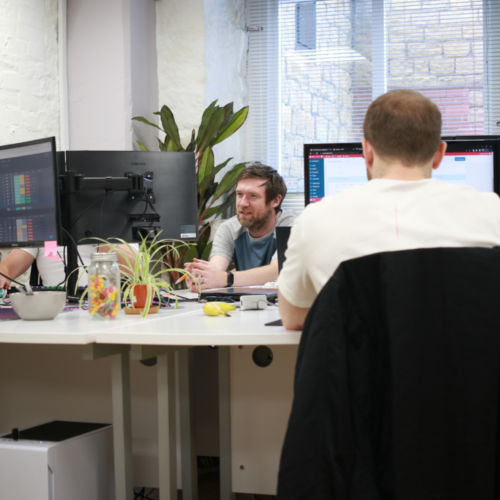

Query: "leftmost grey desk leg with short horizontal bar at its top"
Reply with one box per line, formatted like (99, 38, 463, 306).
(83, 344, 134, 500)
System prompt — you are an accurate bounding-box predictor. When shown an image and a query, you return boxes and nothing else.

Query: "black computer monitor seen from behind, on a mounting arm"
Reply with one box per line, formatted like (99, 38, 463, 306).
(64, 151, 198, 243)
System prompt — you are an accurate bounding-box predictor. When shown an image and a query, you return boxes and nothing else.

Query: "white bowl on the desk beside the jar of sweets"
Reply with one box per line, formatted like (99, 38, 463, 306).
(10, 291, 66, 321)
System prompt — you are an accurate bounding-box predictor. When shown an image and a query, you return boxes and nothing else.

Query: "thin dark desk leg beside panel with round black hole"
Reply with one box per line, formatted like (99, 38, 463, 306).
(219, 346, 235, 500)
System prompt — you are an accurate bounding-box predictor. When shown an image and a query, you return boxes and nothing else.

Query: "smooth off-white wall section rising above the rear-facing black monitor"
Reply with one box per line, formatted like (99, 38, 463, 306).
(67, 0, 132, 150)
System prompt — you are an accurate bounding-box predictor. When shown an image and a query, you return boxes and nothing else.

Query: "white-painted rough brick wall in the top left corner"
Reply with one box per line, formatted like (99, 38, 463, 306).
(0, 0, 59, 145)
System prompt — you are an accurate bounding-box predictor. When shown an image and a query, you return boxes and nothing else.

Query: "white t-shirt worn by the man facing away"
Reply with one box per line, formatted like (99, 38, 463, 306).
(278, 179, 500, 307)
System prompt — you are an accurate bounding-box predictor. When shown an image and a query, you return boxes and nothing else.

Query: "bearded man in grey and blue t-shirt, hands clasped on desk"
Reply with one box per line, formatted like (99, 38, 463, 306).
(186, 163, 297, 291)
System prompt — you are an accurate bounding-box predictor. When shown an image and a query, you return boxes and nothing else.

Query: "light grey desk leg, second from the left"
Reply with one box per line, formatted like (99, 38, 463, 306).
(156, 350, 177, 500)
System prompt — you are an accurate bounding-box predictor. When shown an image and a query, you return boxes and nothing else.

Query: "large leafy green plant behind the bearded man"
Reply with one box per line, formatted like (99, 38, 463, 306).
(133, 101, 248, 286)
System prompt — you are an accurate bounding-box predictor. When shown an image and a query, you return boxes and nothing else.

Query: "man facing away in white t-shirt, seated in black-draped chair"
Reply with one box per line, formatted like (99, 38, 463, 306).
(278, 90, 500, 330)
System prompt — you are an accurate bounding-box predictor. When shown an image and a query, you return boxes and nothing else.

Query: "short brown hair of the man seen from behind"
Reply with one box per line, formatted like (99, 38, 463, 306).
(363, 90, 441, 167)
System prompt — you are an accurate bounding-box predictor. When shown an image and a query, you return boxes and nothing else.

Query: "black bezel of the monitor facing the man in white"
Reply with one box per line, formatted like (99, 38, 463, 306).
(304, 136, 500, 206)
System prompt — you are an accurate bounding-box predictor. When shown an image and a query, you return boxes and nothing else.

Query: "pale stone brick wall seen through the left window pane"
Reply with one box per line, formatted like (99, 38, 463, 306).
(280, 0, 353, 191)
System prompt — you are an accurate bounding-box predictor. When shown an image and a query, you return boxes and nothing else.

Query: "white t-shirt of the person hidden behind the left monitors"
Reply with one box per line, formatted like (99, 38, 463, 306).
(21, 243, 139, 286)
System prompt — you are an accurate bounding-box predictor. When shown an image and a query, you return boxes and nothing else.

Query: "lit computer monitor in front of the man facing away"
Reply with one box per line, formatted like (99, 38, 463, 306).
(304, 138, 500, 205)
